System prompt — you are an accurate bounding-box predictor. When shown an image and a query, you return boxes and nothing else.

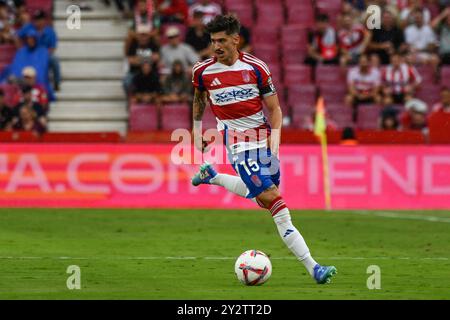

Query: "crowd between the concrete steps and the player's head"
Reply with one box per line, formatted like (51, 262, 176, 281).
(124, 0, 251, 107)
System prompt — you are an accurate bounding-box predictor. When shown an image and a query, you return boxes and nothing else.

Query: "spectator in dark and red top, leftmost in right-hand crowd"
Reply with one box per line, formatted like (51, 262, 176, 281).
(305, 14, 339, 66)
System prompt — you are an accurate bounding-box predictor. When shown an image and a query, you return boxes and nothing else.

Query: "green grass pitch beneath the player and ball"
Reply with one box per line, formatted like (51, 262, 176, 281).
(0, 209, 450, 300)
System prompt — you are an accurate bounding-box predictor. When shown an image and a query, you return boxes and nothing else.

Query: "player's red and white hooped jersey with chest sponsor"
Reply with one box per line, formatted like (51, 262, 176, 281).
(192, 52, 276, 154)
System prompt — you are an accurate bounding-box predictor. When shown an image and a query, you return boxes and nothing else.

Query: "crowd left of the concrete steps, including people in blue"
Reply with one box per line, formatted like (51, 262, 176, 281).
(0, 0, 61, 134)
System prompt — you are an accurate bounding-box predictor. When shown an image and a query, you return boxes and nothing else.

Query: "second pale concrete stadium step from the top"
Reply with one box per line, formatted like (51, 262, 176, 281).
(54, 20, 128, 41)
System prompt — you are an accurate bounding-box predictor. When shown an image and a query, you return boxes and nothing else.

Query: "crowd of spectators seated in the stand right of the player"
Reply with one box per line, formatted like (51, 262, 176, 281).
(305, 0, 450, 133)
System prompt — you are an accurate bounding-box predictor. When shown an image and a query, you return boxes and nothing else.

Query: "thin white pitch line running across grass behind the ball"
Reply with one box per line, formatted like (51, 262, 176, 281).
(0, 256, 450, 261)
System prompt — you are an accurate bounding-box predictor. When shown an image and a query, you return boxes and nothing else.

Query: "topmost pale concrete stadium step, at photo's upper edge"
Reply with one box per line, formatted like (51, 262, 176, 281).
(53, 0, 123, 20)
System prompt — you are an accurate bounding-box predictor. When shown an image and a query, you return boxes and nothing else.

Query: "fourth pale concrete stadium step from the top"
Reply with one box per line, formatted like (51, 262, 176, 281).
(61, 61, 125, 80)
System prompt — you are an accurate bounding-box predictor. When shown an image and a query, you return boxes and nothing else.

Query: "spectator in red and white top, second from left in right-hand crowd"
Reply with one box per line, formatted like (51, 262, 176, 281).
(338, 13, 371, 67)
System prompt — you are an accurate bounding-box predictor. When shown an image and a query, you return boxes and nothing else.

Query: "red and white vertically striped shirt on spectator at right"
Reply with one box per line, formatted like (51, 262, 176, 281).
(382, 63, 422, 94)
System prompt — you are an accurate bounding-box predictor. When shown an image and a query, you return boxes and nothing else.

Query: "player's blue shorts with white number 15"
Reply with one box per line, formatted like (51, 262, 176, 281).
(229, 148, 280, 199)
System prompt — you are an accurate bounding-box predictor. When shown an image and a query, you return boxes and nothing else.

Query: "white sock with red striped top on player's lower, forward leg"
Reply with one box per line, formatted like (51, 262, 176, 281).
(269, 197, 317, 276)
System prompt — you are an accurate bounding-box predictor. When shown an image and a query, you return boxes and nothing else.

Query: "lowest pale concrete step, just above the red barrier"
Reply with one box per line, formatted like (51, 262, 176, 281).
(48, 120, 127, 136)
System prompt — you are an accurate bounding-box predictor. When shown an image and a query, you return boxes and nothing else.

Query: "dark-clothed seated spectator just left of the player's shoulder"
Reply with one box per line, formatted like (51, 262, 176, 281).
(162, 60, 192, 103)
